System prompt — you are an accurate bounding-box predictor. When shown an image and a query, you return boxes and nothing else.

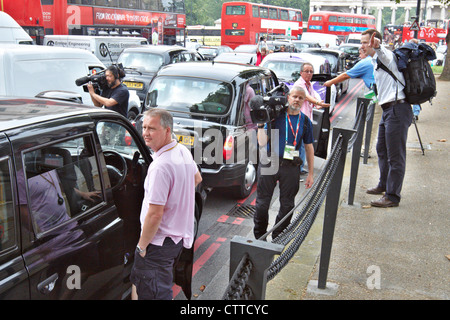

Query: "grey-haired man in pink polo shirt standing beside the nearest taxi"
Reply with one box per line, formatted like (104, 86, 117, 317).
(131, 108, 202, 300)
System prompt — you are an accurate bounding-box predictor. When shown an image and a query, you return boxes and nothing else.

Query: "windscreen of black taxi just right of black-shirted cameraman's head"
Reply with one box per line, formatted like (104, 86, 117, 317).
(117, 52, 164, 72)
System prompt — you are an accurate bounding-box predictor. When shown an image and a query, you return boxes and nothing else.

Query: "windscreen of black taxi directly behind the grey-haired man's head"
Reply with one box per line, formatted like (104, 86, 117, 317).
(147, 77, 233, 115)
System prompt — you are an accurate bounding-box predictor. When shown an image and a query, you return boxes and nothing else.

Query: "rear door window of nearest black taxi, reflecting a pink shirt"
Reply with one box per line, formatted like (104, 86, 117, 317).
(22, 136, 105, 235)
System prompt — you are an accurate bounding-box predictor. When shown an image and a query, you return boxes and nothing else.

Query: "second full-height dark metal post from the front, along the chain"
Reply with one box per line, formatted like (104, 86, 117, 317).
(348, 98, 370, 205)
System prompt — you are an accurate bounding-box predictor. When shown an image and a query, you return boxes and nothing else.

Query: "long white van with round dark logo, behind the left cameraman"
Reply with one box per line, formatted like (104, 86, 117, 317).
(44, 35, 148, 66)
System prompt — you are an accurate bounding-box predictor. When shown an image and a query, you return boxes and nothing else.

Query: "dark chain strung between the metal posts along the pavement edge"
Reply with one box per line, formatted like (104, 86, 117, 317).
(222, 101, 370, 300)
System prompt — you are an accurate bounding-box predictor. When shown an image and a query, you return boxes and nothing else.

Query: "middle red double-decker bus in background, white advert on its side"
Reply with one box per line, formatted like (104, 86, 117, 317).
(221, 1, 303, 49)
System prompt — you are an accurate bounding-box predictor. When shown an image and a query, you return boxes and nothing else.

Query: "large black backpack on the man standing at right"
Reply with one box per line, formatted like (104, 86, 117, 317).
(377, 42, 436, 104)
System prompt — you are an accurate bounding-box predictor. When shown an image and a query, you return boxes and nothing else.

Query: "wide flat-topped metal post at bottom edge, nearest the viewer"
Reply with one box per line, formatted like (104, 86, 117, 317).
(230, 236, 284, 300)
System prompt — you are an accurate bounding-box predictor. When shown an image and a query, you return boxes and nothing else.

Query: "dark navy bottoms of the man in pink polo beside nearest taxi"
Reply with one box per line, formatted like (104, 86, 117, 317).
(131, 237, 183, 300)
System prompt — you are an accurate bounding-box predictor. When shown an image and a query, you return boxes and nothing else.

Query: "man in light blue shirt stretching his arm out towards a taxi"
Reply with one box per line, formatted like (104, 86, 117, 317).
(323, 48, 375, 89)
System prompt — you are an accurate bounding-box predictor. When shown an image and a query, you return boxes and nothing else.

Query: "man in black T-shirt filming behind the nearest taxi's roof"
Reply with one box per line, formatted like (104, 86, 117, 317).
(87, 65, 130, 117)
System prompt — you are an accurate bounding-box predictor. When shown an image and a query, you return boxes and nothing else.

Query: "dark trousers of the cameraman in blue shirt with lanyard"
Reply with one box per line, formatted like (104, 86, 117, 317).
(253, 165, 300, 239)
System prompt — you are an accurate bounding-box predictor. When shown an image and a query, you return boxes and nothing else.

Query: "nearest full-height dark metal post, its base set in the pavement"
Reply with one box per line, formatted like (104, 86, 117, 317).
(318, 127, 356, 289)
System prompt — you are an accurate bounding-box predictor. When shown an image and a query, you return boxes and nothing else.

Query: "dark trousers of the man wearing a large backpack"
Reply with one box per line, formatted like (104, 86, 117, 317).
(377, 103, 413, 202)
